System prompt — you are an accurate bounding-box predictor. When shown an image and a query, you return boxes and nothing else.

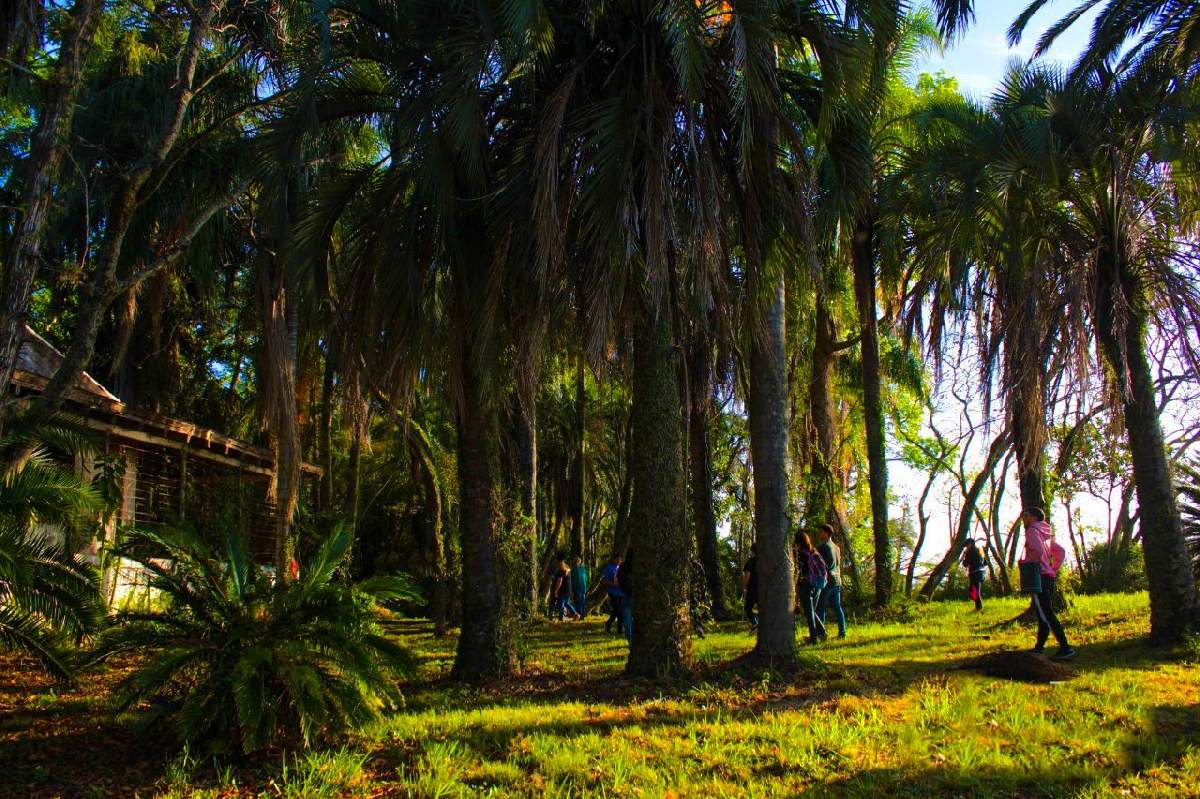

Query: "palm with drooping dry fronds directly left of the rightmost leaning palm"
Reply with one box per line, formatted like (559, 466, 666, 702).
(898, 70, 1079, 523)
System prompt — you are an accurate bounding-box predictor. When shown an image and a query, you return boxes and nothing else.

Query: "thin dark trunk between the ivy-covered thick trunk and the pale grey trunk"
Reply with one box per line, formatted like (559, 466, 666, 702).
(688, 325, 732, 619)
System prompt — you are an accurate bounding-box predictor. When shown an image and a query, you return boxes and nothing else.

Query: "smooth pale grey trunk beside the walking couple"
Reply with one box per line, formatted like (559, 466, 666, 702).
(748, 281, 796, 660)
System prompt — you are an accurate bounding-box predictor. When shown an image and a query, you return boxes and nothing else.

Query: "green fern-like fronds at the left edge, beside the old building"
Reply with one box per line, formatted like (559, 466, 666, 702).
(0, 417, 103, 679)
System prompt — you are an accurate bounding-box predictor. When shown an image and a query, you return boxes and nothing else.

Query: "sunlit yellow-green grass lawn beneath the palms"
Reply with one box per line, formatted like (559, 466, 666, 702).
(0, 587, 1200, 799)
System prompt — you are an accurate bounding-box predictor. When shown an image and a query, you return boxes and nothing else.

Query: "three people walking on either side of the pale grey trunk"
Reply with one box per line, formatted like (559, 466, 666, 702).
(742, 524, 846, 644)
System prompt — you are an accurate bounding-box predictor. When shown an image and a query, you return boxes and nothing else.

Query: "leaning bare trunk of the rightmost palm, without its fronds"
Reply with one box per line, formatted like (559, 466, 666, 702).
(1097, 257, 1200, 643)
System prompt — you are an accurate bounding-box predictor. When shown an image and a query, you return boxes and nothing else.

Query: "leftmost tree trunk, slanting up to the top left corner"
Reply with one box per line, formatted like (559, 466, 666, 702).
(0, 0, 104, 420)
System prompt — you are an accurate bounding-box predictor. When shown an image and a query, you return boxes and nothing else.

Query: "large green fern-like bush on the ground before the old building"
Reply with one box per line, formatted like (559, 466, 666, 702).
(97, 525, 416, 755)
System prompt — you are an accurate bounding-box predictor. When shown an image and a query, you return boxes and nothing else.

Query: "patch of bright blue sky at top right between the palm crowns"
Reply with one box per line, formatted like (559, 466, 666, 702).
(918, 0, 1096, 100)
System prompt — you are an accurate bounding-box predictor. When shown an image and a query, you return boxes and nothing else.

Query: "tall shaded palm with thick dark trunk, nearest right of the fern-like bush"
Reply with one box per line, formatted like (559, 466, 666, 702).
(272, 0, 549, 680)
